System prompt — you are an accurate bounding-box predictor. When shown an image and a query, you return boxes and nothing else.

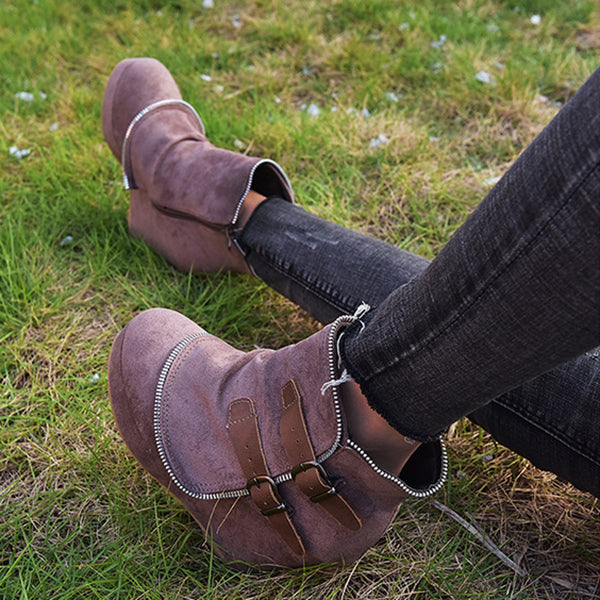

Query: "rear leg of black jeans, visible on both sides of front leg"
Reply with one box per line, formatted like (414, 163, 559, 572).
(240, 198, 600, 497)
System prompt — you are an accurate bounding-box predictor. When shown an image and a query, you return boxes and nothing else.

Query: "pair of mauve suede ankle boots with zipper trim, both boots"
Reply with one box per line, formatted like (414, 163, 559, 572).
(102, 58, 446, 567)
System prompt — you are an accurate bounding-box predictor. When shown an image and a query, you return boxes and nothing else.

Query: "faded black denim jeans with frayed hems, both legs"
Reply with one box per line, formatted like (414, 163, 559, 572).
(241, 65, 600, 496)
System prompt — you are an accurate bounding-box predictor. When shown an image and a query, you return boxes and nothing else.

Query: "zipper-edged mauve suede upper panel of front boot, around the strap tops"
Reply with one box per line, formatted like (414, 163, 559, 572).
(160, 318, 337, 494)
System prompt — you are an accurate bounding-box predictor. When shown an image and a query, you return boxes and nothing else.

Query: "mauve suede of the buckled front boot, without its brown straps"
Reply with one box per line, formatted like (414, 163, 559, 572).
(109, 309, 439, 568)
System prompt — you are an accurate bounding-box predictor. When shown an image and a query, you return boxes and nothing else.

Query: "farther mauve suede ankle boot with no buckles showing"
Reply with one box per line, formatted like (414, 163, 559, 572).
(102, 58, 293, 272)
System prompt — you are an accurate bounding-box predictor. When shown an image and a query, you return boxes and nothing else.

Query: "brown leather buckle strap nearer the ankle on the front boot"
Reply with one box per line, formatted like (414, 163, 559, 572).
(280, 379, 362, 530)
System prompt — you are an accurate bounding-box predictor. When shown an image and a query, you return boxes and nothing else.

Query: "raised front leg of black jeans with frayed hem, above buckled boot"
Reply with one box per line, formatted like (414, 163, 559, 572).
(340, 64, 600, 440)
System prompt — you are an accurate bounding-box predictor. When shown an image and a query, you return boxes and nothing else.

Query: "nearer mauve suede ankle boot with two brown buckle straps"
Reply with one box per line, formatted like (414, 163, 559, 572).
(109, 309, 447, 568)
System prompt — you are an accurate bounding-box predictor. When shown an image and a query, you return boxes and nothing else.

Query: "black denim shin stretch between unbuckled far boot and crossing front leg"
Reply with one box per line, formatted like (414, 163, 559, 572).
(239, 198, 430, 324)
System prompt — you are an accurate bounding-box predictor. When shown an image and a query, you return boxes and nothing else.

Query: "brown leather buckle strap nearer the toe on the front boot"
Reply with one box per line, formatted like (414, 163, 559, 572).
(227, 398, 306, 556)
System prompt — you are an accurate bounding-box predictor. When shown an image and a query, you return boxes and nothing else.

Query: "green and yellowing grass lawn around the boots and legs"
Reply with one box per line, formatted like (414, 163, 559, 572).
(0, 0, 600, 600)
